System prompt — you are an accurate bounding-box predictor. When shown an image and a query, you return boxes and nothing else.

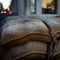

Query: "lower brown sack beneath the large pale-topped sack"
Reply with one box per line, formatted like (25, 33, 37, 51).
(2, 41, 47, 60)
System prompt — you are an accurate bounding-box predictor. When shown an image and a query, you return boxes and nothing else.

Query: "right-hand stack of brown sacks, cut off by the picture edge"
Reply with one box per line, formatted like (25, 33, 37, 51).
(39, 17, 60, 60)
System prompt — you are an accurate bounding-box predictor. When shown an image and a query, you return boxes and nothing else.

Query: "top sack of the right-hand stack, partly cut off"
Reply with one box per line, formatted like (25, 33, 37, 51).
(40, 17, 60, 39)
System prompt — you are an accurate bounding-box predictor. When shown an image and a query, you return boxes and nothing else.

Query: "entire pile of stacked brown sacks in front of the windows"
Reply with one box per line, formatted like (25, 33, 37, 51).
(0, 16, 60, 60)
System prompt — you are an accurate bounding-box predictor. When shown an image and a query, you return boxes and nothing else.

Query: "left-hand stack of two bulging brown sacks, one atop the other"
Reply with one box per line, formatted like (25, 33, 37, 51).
(0, 16, 51, 60)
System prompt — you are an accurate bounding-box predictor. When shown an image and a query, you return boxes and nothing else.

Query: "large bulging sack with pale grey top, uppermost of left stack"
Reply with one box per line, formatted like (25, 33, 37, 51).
(0, 17, 51, 45)
